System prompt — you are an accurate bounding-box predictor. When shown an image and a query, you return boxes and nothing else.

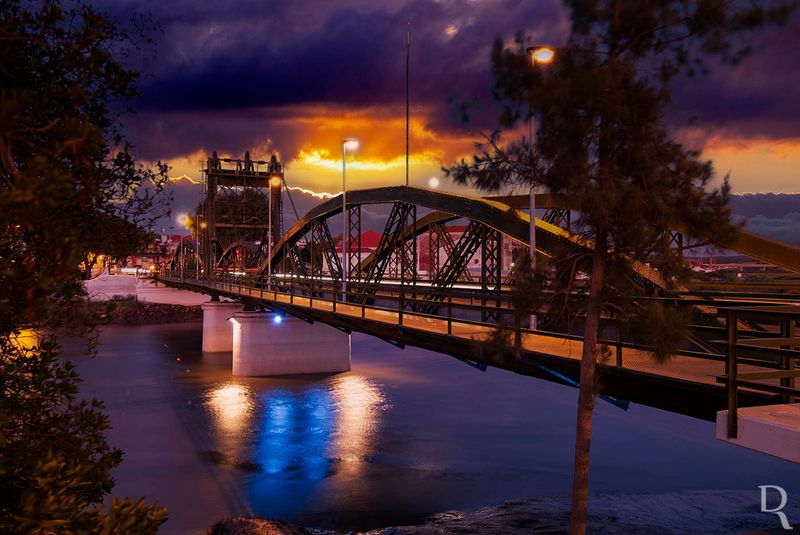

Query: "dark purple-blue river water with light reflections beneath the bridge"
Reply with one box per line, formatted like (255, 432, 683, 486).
(67, 322, 800, 534)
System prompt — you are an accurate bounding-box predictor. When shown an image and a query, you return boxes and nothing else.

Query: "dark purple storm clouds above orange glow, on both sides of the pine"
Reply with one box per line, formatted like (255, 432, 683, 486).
(90, 0, 800, 165)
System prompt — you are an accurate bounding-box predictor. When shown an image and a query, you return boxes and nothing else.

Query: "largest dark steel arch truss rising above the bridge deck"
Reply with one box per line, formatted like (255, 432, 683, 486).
(258, 186, 666, 300)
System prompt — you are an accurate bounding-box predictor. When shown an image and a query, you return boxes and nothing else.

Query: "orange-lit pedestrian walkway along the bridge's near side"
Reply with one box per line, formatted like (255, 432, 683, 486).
(163, 279, 792, 420)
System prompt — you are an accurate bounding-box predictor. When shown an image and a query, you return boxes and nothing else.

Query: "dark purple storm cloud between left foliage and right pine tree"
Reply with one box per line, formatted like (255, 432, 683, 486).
(97, 0, 566, 157)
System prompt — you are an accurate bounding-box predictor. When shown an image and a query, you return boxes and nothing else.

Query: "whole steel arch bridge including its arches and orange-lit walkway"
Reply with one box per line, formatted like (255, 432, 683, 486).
(164, 186, 800, 418)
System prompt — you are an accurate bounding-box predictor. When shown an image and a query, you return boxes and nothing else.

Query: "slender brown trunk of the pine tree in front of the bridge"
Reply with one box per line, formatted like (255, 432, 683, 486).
(569, 240, 607, 535)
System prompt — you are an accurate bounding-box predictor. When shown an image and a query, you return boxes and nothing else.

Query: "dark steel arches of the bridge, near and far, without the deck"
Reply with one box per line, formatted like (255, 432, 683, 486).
(170, 186, 800, 286)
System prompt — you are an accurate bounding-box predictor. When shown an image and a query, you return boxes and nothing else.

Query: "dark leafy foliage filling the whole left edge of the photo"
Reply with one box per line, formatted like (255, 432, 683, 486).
(0, 0, 167, 533)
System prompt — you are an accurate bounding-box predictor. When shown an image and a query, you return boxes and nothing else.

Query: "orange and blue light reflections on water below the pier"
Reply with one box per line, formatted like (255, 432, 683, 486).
(204, 374, 387, 480)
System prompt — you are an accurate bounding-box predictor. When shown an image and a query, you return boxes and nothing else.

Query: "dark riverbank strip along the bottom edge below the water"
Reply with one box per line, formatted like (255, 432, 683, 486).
(210, 489, 800, 535)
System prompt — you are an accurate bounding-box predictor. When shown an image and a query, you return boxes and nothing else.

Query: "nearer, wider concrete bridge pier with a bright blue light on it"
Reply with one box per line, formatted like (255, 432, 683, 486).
(231, 312, 350, 377)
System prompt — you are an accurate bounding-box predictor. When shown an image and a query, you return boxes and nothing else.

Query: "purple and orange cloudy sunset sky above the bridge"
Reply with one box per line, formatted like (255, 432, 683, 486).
(93, 0, 800, 234)
